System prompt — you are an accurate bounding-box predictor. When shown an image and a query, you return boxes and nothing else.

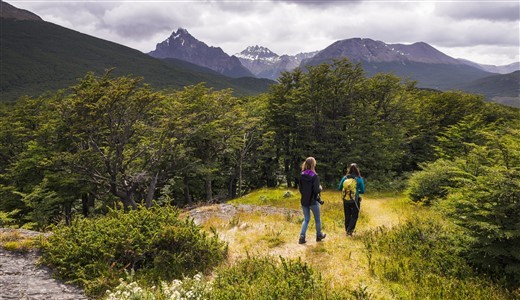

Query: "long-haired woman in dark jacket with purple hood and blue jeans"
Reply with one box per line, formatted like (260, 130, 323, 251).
(298, 157, 326, 244)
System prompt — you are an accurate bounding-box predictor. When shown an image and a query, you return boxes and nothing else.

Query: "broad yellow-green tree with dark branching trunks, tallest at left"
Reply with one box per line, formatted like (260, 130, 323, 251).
(59, 72, 172, 208)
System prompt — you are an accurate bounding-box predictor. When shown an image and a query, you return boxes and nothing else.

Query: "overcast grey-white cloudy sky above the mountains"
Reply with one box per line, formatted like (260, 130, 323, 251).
(6, 0, 520, 65)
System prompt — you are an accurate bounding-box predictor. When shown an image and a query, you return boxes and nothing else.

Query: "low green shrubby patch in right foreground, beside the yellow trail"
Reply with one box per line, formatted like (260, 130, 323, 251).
(363, 218, 513, 299)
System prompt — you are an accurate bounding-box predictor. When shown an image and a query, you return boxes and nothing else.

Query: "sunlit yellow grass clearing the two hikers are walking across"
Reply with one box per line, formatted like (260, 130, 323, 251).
(190, 189, 418, 294)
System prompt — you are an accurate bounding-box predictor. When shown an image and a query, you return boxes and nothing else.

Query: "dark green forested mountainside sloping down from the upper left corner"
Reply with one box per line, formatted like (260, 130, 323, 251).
(0, 1, 273, 102)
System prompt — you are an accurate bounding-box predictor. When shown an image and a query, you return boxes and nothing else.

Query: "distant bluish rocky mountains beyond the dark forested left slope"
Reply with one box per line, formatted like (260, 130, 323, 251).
(149, 28, 520, 106)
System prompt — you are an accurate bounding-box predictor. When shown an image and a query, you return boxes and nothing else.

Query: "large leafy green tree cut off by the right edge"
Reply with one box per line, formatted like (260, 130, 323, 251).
(445, 121, 520, 288)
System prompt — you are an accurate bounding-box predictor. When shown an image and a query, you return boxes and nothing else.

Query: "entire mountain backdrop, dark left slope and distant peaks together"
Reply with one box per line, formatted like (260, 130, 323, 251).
(0, 1, 520, 107)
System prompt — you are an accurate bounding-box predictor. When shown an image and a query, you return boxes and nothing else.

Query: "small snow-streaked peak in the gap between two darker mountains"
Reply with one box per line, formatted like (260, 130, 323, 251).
(235, 45, 317, 80)
